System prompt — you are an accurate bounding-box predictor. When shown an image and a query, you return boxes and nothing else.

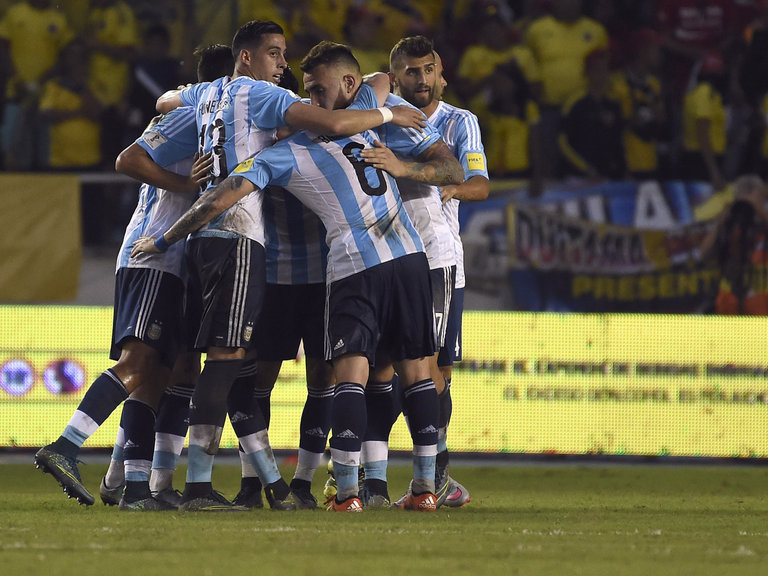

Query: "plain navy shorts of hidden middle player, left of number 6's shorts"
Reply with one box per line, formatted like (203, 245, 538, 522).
(254, 283, 325, 362)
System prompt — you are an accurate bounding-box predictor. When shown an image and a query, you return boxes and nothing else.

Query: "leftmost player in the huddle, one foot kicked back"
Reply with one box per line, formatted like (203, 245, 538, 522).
(35, 49, 231, 510)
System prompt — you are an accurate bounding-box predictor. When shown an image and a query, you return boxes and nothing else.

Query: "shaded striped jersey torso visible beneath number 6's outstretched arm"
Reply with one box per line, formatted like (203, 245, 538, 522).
(263, 186, 328, 284)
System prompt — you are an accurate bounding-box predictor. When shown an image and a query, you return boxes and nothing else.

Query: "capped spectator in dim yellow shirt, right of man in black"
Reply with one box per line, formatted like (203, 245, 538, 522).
(610, 28, 667, 180)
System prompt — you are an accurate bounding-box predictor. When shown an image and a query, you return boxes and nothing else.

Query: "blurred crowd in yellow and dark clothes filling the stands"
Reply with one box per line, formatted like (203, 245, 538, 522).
(0, 0, 768, 195)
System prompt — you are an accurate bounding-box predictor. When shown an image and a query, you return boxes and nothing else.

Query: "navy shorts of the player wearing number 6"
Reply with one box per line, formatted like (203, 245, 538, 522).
(325, 252, 435, 365)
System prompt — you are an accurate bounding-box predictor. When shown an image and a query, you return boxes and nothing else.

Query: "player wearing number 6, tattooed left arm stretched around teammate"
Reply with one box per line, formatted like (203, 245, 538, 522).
(134, 59, 444, 511)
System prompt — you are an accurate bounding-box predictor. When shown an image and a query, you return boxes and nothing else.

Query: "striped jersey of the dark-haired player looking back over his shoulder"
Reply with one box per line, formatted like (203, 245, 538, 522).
(180, 76, 299, 245)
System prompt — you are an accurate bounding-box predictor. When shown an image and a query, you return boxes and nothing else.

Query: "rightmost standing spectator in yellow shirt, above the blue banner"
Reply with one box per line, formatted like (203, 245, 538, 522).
(679, 52, 727, 190)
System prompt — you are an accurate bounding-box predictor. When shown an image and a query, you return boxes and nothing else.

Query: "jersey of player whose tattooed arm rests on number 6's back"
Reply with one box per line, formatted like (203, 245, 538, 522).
(377, 94, 456, 270)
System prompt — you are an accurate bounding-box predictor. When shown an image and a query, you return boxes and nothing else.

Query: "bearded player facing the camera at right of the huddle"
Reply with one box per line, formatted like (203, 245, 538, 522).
(390, 36, 490, 507)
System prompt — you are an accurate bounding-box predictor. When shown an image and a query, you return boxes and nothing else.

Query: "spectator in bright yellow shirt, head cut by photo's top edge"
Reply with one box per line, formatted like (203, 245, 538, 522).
(525, 0, 608, 175)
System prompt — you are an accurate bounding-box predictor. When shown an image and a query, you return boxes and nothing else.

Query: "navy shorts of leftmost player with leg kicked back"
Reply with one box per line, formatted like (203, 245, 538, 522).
(109, 268, 184, 366)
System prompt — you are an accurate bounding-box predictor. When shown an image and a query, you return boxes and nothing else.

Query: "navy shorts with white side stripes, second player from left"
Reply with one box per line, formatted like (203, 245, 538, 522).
(187, 237, 266, 352)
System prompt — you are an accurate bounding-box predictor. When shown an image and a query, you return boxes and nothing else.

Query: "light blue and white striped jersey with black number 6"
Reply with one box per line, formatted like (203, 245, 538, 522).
(233, 131, 424, 284)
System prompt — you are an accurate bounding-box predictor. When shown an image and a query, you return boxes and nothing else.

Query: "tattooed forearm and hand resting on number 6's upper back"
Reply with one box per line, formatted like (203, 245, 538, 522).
(360, 139, 464, 186)
